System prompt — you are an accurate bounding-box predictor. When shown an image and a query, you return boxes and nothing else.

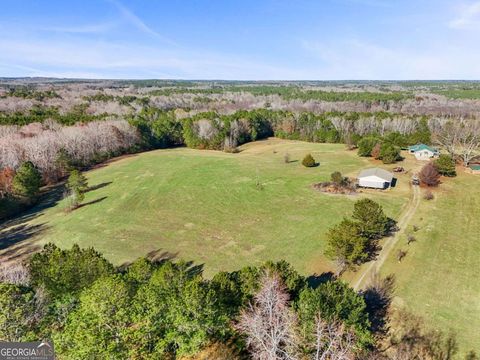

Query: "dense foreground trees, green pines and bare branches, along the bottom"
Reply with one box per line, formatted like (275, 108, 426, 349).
(0, 244, 464, 360)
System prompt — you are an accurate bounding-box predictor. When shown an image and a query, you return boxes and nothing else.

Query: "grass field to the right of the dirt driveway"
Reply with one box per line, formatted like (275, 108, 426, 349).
(383, 171, 480, 353)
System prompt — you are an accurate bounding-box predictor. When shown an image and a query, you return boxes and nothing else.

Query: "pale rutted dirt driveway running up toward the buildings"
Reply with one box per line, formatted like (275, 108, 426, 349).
(353, 181, 420, 291)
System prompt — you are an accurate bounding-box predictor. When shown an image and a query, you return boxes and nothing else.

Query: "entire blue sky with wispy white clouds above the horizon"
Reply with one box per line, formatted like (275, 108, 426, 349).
(0, 0, 480, 80)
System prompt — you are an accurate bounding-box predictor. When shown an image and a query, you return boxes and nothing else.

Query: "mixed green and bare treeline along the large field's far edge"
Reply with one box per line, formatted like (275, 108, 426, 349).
(129, 108, 431, 151)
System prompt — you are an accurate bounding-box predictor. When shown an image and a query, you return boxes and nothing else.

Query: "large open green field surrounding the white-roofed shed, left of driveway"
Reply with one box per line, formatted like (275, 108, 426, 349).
(4, 139, 408, 275)
